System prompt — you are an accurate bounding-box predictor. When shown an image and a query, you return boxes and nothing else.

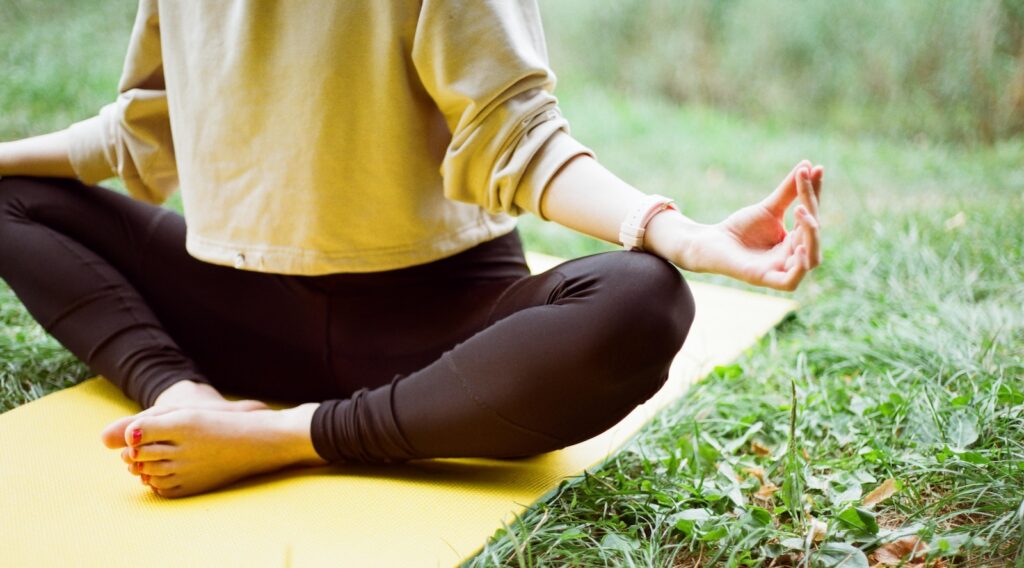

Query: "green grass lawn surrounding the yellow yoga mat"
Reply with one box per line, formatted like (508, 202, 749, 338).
(6, 3, 1024, 566)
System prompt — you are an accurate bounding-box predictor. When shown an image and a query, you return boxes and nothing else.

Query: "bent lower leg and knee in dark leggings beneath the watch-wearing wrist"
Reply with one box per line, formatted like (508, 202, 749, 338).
(311, 252, 694, 463)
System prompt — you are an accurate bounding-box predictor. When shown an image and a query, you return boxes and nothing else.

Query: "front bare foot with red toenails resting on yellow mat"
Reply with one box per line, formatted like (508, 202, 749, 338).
(103, 404, 327, 497)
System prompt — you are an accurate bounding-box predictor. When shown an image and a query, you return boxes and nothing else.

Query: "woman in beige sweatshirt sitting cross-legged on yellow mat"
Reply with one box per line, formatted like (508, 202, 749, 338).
(0, 0, 822, 497)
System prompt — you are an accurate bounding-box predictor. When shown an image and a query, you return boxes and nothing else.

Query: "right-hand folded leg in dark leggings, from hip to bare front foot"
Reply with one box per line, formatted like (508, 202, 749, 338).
(103, 234, 693, 497)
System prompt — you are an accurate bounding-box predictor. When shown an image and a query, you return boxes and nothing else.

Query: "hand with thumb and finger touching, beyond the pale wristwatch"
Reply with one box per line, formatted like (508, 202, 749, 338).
(686, 161, 824, 291)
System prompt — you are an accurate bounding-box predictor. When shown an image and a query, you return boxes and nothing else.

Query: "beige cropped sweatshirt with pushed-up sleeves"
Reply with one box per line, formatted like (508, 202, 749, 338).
(70, 0, 591, 274)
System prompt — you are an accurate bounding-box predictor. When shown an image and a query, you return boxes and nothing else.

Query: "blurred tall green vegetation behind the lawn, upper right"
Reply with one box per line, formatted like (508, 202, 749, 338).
(544, 0, 1024, 142)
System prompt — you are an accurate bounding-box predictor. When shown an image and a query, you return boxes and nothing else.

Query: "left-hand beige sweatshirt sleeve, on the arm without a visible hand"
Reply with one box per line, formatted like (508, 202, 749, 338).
(69, 0, 178, 204)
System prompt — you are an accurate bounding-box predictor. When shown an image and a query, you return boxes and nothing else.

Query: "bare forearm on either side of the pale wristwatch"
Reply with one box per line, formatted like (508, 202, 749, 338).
(541, 156, 705, 268)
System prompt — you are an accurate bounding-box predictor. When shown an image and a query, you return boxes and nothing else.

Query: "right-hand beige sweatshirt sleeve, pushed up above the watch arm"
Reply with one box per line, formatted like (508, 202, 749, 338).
(413, 0, 593, 219)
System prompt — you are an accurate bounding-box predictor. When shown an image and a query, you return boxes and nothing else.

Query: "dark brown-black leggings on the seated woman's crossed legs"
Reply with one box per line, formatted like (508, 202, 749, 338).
(0, 177, 694, 463)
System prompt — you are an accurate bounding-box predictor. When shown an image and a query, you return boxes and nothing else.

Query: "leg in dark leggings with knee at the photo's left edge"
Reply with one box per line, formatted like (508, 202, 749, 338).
(0, 178, 340, 407)
